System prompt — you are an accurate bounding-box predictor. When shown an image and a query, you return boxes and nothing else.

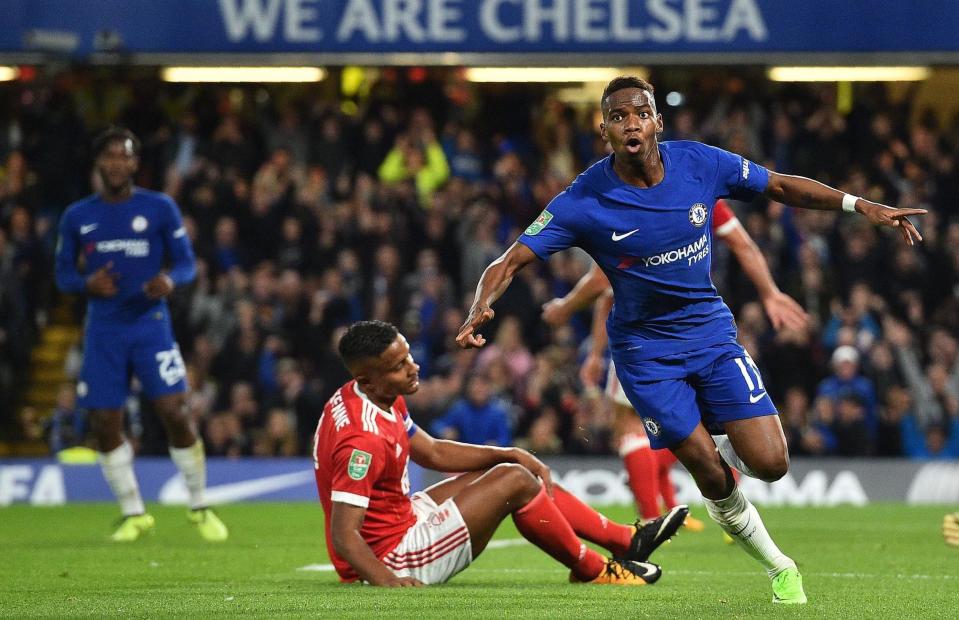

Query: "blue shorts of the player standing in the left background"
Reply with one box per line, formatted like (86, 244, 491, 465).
(77, 313, 187, 409)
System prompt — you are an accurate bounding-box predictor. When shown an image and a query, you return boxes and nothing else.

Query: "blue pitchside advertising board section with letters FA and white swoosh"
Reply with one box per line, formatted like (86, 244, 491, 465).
(0, 457, 423, 506)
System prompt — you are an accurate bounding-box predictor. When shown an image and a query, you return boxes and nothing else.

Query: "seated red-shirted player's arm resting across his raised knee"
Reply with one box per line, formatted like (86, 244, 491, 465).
(410, 428, 553, 495)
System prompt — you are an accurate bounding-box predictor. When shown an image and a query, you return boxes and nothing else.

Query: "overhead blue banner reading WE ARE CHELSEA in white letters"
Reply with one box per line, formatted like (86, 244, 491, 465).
(0, 0, 959, 57)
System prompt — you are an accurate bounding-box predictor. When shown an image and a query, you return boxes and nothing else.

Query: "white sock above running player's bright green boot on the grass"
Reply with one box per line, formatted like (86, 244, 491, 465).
(703, 486, 796, 577)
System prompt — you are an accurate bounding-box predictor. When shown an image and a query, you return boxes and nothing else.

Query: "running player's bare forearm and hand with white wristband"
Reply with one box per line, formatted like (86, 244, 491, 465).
(763, 172, 927, 245)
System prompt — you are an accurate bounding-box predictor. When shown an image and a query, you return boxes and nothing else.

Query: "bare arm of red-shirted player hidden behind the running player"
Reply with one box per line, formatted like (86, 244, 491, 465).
(721, 225, 809, 330)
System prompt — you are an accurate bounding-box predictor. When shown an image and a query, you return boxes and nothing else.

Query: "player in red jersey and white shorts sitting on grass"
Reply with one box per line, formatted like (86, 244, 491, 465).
(313, 321, 688, 586)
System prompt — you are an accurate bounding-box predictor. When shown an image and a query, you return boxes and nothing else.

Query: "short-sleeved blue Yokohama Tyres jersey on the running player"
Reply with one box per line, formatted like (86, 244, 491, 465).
(519, 141, 769, 363)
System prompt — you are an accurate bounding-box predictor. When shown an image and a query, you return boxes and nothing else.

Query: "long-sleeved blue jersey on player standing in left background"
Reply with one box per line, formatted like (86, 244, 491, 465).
(56, 187, 196, 322)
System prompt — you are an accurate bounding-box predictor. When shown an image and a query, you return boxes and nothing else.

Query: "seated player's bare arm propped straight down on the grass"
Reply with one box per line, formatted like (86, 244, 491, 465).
(330, 502, 423, 587)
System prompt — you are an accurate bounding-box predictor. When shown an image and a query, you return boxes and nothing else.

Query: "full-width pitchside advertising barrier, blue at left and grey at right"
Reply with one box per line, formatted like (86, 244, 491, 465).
(0, 457, 959, 506)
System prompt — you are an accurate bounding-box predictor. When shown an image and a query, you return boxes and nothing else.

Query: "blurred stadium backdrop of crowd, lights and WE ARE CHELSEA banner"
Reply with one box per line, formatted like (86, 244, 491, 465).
(0, 0, 959, 501)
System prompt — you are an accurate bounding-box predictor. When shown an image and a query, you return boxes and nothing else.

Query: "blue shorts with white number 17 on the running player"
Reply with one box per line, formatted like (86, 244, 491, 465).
(616, 342, 777, 449)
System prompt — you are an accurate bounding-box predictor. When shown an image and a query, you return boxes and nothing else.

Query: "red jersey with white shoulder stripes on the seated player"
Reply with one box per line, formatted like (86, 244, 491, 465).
(313, 381, 417, 581)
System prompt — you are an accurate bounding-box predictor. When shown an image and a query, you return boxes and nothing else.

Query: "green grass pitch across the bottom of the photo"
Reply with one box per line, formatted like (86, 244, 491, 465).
(0, 504, 959, 619)
